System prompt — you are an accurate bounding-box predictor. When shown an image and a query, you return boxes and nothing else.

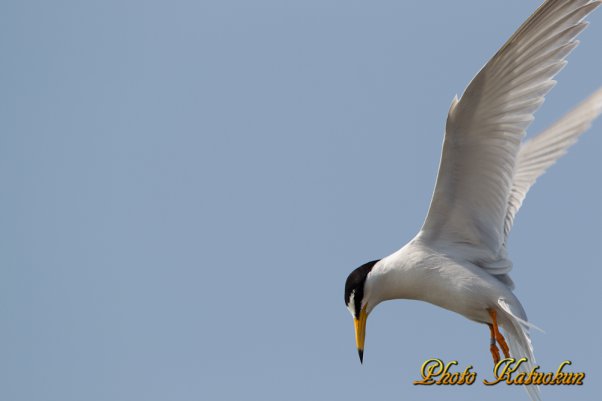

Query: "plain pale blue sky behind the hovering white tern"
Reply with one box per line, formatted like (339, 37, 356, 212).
(0, 0, 602, 401)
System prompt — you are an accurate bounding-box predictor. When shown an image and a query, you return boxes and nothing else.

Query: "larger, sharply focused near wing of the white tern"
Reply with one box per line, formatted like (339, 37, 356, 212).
(419, 0, 601, 268)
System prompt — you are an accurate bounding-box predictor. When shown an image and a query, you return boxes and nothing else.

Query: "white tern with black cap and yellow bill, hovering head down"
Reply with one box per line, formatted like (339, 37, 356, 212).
(345, 0, 602, 399)
